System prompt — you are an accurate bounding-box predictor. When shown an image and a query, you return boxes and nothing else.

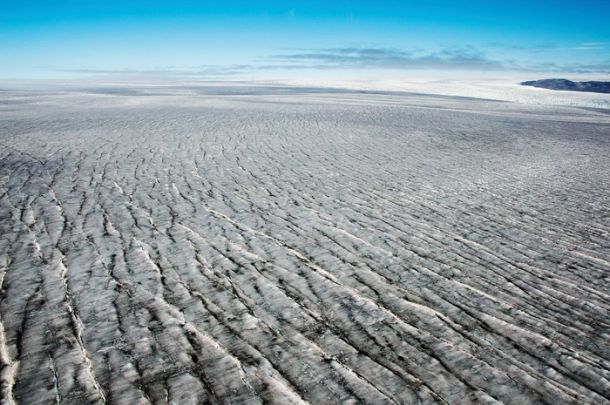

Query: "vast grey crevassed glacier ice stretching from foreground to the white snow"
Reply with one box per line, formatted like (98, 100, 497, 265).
(0, 86, 610, 405)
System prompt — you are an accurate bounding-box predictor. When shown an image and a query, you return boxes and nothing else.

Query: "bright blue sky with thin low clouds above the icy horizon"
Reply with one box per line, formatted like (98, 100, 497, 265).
(0, 0, 610, 79)
